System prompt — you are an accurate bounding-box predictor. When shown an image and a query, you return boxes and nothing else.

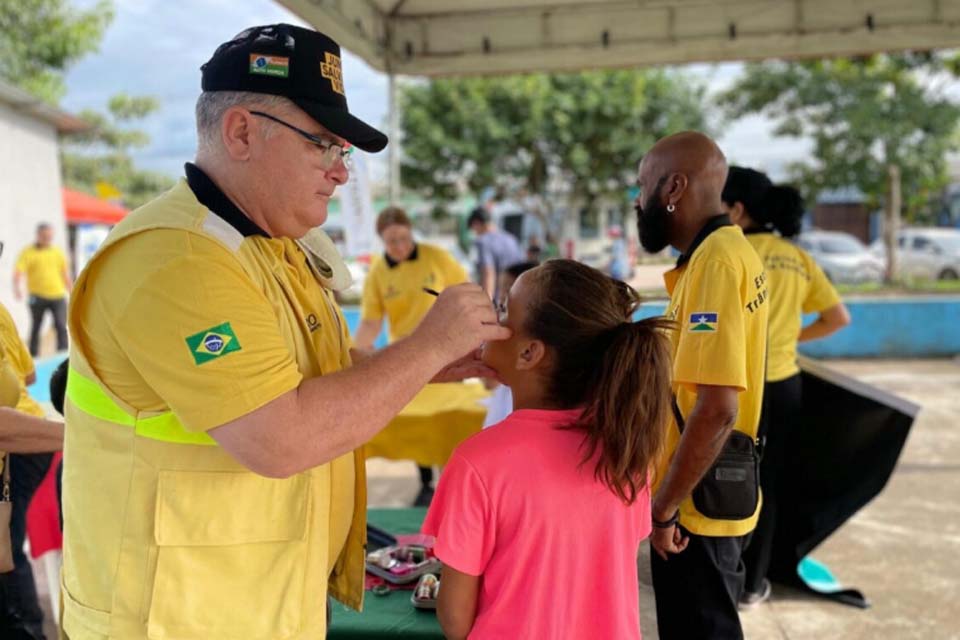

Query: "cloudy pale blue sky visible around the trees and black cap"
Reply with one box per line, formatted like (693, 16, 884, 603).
(63, 0, 807, 185)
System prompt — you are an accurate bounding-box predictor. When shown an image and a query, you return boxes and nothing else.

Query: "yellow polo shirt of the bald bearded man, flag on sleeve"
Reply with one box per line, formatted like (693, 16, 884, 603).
(657, 216, 770, 536)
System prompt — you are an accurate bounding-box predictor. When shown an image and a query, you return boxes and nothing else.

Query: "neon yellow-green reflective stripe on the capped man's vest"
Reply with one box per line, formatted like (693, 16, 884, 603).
(67, 367, 217, 446)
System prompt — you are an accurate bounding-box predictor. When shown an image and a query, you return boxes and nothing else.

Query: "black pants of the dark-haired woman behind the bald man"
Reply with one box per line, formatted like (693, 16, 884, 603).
(743, 374, 803, 593)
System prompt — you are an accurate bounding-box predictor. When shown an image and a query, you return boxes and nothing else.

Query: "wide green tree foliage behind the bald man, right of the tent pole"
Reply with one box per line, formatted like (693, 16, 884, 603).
(401, 70, 706, 208)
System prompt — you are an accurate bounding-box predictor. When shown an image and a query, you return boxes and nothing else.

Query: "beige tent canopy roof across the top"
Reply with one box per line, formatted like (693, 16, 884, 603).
(279, 0, 960, 76)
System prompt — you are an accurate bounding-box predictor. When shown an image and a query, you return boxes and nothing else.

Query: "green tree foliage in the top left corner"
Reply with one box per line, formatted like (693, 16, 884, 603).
(0, 0, 113, 104)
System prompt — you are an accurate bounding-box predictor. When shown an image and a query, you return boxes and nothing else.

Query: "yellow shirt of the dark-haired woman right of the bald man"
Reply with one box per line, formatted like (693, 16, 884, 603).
(747, 232, 840, 382)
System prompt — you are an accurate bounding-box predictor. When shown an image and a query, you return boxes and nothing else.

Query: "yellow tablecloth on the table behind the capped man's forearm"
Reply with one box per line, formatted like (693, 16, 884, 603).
(366, 382, 490, 466)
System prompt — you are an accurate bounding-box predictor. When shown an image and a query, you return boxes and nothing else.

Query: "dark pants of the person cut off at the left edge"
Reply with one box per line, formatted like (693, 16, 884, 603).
(0, 453, 52, 640)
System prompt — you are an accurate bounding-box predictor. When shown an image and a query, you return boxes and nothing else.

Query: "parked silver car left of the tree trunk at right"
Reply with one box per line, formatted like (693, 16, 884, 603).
(797, 230, 884, 284)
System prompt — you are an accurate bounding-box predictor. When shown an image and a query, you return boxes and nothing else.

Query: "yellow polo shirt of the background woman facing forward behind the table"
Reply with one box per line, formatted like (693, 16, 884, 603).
(362, 244, 468, 342)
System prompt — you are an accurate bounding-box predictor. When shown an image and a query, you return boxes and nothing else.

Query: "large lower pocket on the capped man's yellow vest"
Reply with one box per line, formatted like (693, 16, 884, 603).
(147, 471, 310, 640)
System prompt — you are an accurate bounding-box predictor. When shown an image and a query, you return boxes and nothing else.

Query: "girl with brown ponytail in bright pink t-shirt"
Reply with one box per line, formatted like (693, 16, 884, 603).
(423, 260, 671, 639)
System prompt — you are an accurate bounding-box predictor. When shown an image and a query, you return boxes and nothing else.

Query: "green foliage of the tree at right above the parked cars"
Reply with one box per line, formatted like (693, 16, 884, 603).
(721, 53, 960, 222)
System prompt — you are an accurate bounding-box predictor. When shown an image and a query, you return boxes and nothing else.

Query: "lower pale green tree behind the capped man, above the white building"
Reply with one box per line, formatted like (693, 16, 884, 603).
(62, 94, 173, 208)
